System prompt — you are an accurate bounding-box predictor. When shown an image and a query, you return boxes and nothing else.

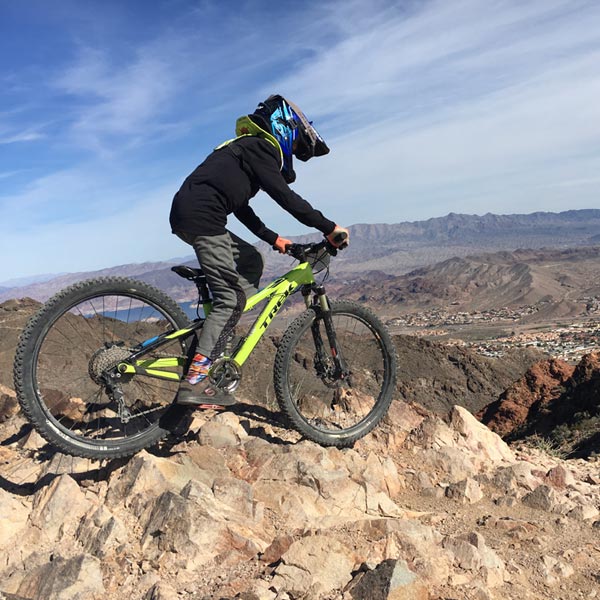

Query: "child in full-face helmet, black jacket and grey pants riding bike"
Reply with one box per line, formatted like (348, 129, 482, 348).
(169, 95, 349, 408)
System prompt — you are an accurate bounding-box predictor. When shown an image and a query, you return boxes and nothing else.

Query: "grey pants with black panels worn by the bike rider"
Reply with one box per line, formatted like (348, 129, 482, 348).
(176, 231, 264, 360)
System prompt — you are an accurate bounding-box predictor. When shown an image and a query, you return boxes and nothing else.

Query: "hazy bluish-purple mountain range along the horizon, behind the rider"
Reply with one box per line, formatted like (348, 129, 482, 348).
(0, 209, 600, 302)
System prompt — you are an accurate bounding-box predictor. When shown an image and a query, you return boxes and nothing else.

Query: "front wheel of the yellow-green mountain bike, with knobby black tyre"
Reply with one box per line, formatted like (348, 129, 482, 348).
(274, 302, 397, 448)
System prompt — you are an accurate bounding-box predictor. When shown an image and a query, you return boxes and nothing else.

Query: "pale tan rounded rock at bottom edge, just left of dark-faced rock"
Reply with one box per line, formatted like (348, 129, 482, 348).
(272, 535, 354, 598)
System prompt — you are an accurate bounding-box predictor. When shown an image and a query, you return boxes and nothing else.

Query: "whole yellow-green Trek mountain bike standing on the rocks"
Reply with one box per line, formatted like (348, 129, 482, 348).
(14, 241, 397, 459)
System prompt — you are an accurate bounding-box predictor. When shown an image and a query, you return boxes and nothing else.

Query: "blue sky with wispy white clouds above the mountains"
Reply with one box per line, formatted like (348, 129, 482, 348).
(0, 0, 600, 282)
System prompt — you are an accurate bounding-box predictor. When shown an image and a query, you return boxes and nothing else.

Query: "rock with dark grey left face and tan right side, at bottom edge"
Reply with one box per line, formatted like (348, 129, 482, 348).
(347, 559, 429, 600)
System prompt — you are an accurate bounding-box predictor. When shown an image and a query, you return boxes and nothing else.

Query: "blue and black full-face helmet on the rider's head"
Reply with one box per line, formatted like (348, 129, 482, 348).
(250, 95, 329, 183)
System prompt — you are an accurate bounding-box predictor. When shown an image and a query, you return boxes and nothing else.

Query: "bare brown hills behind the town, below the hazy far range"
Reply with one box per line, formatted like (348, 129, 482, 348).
(333, 246, 600, 320)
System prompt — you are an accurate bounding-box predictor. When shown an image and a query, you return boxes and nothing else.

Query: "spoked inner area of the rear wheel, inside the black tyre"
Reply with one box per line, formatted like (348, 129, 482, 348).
(28, 293, 185, 454)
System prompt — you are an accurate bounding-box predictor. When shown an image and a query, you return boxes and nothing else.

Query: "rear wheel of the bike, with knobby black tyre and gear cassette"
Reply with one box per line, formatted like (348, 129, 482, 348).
(14, 277, 189, 459)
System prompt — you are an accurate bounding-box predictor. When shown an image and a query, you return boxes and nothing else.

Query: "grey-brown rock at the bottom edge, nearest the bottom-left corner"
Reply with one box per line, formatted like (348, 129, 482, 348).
(16, 554, 105, 600)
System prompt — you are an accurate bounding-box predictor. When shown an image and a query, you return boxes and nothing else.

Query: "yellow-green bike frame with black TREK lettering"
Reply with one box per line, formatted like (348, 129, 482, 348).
(117, 262, 315, 381)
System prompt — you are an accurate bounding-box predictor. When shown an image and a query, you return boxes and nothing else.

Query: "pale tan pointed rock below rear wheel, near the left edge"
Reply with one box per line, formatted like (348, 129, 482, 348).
(30, 474, 92, 541)
